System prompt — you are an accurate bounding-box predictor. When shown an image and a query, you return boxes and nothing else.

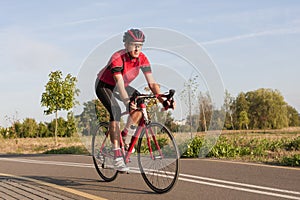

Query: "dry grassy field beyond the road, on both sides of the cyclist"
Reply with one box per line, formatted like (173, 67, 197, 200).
(0, 127, 300, 166)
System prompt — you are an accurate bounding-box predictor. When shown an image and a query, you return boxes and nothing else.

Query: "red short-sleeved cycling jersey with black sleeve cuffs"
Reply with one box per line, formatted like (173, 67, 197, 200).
(98, 49, 151, 86)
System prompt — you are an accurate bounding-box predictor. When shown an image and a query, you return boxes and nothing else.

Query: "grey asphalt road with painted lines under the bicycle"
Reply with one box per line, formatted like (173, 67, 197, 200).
(0, 155, 300, 200)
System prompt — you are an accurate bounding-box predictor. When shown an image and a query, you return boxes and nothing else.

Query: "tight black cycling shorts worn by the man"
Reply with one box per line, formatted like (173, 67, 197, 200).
(95, 79, 139, 122)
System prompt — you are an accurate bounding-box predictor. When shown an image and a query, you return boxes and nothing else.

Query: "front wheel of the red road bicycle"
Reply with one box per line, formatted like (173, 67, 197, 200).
(137, 122, 180, 194)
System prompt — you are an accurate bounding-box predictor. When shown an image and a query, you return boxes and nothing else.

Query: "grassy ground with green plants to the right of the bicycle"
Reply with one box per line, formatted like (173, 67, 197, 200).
(182, 133, 300, 166)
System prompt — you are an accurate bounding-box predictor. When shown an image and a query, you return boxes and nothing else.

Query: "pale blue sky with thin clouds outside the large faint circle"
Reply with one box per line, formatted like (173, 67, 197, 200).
(0, 0, 300, 126)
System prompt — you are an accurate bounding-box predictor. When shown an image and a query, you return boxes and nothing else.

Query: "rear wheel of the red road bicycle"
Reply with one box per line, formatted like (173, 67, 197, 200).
(92, 122, 118, 182)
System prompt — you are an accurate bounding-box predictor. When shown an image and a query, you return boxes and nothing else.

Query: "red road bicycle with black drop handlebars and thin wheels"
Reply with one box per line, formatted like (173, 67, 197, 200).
(92, 90, 180, 193)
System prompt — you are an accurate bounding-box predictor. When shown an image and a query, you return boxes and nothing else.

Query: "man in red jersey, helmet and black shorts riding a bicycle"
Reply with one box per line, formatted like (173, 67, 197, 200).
(96, 29, 171, 172)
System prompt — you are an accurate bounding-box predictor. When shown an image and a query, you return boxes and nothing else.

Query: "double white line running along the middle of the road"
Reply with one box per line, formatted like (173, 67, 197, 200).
(0, 158, 300, 200)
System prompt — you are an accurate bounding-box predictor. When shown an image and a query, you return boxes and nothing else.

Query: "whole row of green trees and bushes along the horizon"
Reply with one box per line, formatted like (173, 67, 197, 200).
(0, 71, 300, 138)
